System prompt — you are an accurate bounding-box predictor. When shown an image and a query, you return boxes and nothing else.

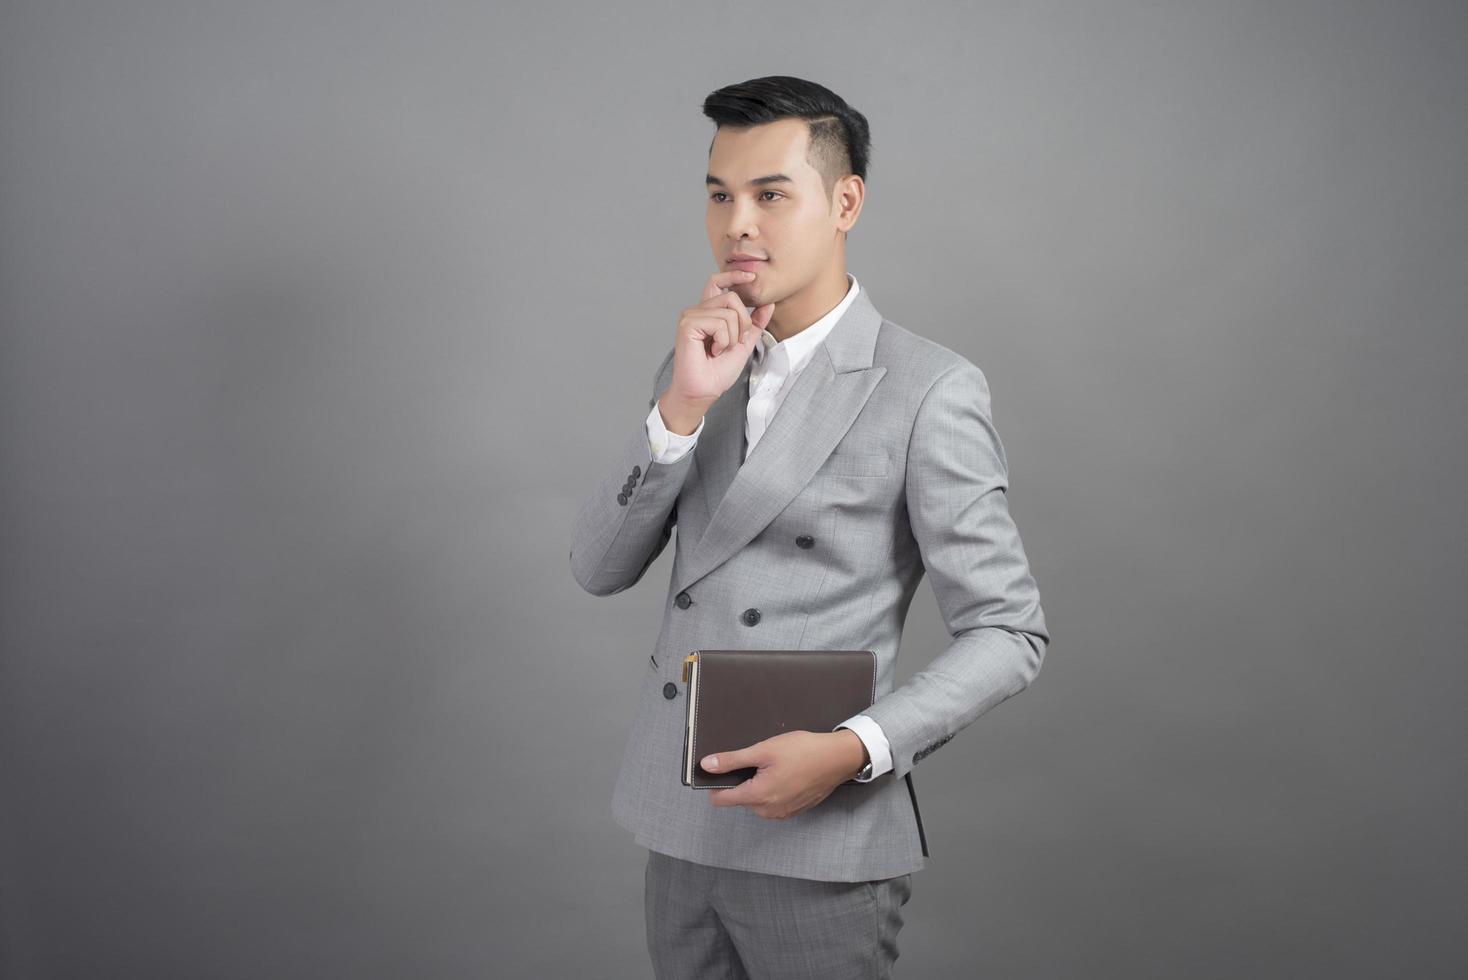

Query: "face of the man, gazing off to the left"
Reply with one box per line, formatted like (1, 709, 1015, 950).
(705, 119, 840, 307)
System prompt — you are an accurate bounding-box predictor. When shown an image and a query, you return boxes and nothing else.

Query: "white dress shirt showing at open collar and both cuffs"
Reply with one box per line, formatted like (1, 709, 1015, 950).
(647, 273, 893, 782)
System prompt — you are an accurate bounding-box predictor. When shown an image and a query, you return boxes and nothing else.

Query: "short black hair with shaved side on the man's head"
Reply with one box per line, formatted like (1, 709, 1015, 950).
(703, 75, 872, 200)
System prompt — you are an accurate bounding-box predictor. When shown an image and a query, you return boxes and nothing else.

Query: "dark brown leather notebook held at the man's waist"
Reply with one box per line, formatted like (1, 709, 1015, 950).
(683, 650, 876, 789)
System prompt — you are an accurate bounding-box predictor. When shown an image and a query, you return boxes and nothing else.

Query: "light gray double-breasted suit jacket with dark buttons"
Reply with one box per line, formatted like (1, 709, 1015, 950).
(570, 281, 1050, 882)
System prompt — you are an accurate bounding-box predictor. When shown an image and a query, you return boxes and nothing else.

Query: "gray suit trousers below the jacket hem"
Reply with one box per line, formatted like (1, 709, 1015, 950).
(646, 849, 912, 980)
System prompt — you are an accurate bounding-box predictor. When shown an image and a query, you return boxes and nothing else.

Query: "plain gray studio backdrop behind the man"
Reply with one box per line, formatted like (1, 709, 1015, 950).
(0, 1, 1468, 980)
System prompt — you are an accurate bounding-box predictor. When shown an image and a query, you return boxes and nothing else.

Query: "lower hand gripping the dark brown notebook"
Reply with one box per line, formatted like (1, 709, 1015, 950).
(700, 728, 868, 820)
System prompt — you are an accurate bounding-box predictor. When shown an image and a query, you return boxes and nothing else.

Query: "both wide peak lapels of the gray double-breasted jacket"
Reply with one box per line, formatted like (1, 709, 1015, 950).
(674, 288, 887, 591)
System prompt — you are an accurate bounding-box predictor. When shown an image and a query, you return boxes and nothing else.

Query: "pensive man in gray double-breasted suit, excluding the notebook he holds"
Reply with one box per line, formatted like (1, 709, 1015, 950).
(570, 76, 1050, 980)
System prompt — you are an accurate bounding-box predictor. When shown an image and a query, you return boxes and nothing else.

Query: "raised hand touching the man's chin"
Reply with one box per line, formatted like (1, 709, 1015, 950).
(658, 268, 775, 436)
